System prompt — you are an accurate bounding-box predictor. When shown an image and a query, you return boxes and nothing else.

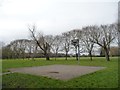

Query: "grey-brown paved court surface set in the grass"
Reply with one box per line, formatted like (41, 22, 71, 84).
(9, 65, 105, 80)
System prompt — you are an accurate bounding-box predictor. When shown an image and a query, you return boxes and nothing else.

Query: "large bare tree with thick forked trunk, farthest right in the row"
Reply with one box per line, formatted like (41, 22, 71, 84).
(89, 24, 116, 61)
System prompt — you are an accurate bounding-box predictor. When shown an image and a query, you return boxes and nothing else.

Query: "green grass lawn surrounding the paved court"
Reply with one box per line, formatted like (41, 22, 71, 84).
(2, 57, 118, 88)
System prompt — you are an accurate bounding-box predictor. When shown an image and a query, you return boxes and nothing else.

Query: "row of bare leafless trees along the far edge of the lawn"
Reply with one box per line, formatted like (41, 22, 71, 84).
(2, 23, 118, 61)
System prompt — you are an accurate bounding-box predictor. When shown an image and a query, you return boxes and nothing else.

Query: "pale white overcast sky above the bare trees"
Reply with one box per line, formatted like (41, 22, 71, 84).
(0, 0, 118, 43)
